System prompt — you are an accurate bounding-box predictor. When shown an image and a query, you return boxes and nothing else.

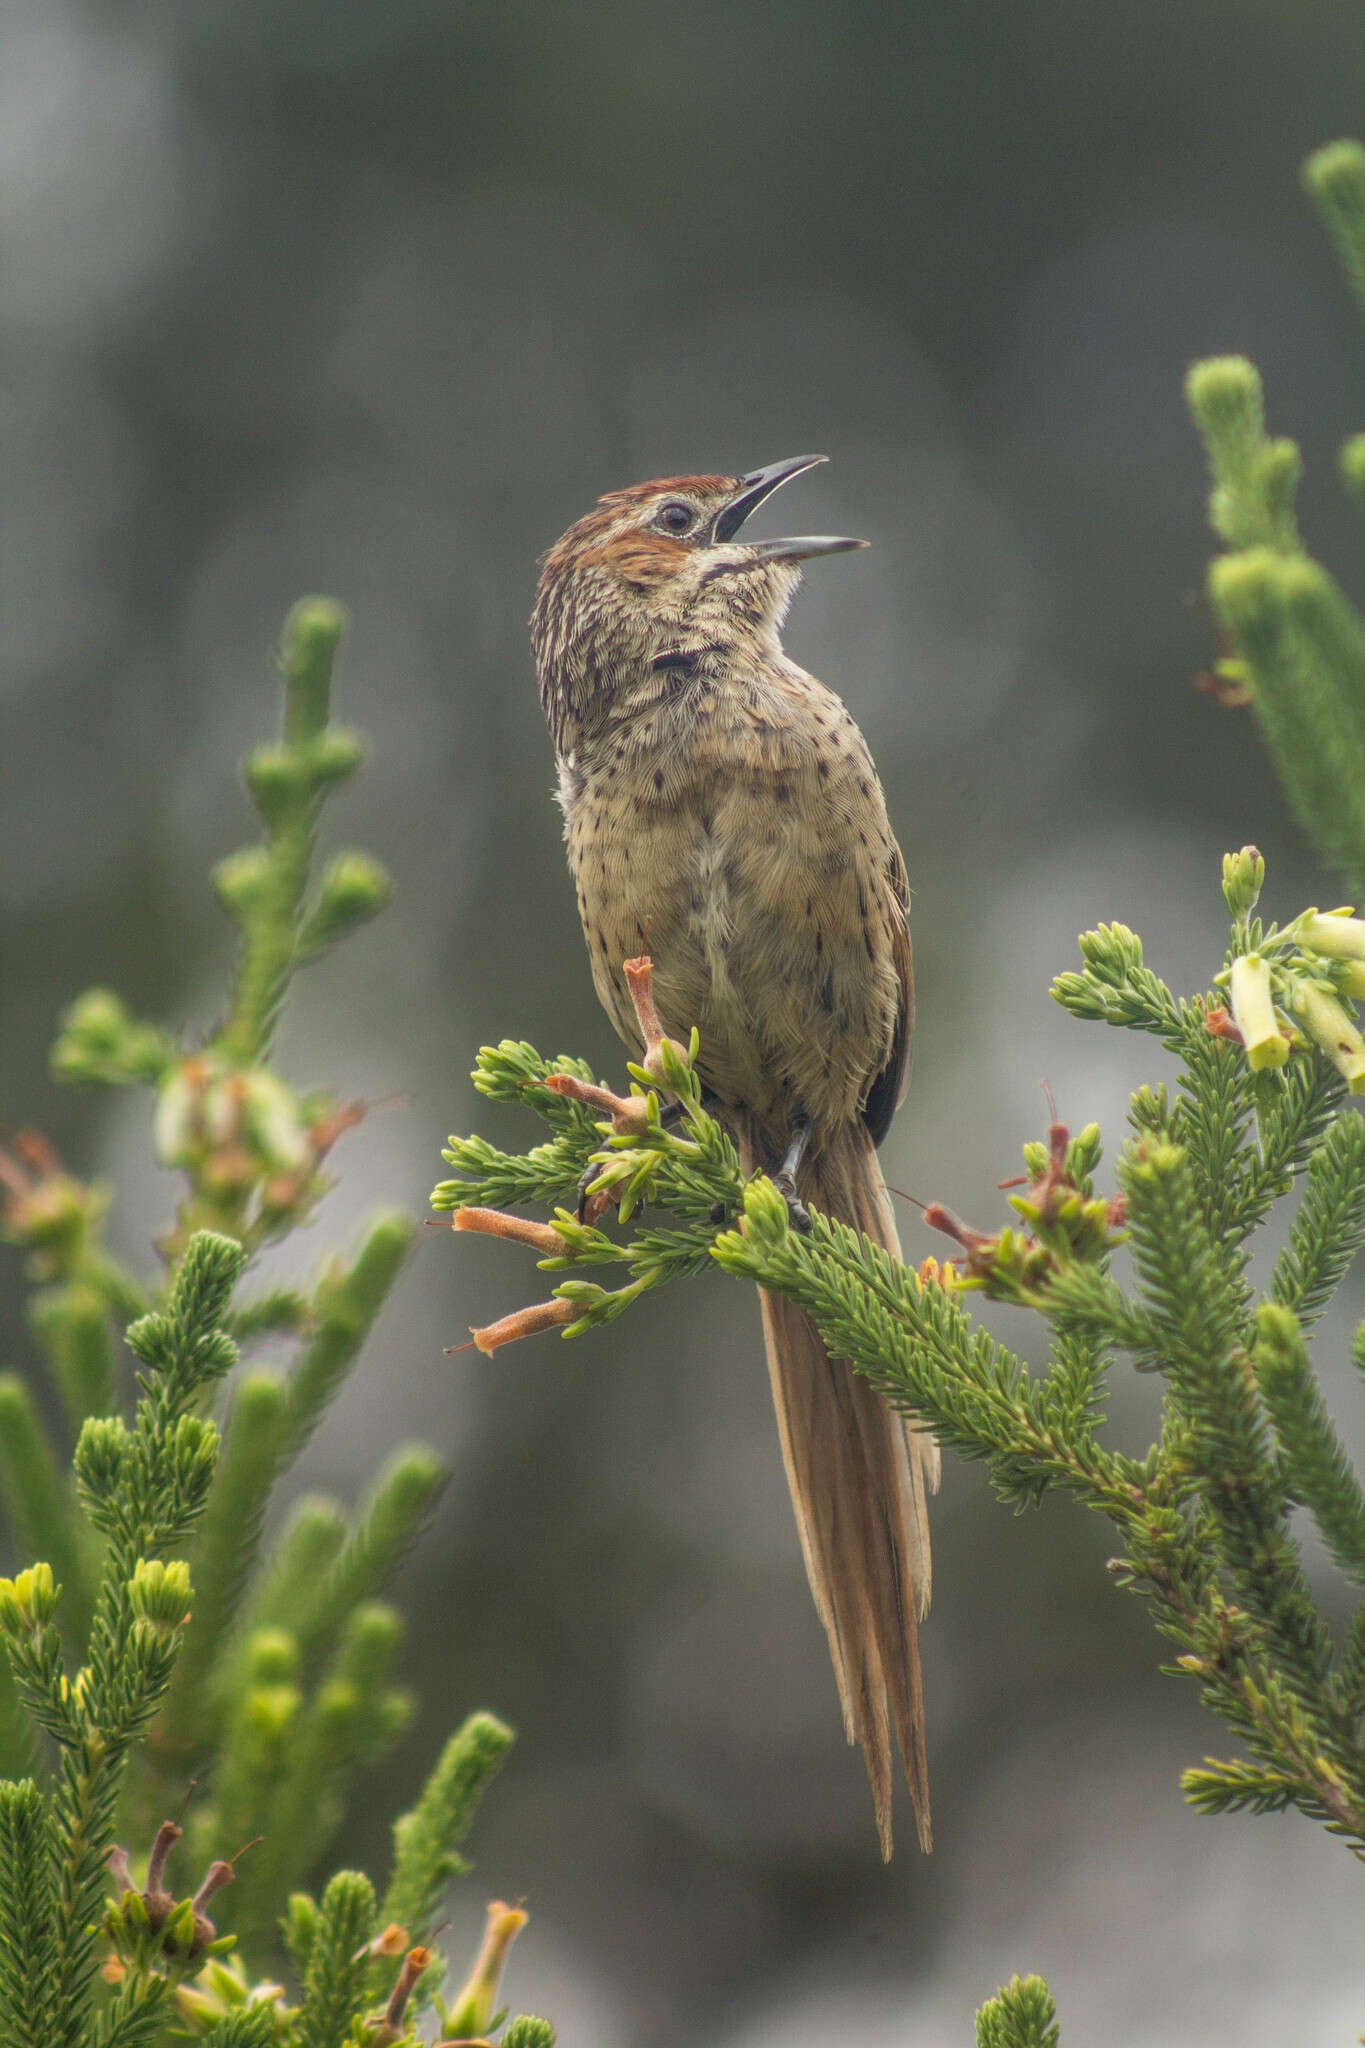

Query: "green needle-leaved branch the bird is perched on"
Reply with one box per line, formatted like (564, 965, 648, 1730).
(436, 850, 1365, 1900)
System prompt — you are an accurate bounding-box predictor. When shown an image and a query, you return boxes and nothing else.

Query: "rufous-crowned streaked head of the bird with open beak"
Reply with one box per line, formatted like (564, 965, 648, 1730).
(530, 455, 866, 750)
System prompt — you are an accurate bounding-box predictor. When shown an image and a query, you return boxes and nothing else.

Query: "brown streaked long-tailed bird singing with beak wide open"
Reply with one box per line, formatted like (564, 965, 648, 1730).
(532, 455, 939, 1855)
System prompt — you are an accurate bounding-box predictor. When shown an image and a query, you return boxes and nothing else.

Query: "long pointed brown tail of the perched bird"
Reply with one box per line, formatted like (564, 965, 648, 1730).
(741, 1124, 939, 1858)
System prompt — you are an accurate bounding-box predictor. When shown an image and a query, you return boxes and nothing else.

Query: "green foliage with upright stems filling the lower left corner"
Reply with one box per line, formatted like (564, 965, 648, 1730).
(0, 600, 544, 2048)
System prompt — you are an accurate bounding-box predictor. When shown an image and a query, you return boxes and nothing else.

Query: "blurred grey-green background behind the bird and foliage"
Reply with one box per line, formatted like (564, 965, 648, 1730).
(0, 0, 1365, 2048)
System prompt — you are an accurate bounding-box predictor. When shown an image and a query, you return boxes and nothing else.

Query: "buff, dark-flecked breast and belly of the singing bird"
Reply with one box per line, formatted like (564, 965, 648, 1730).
(569, 754, 905, 1147)
